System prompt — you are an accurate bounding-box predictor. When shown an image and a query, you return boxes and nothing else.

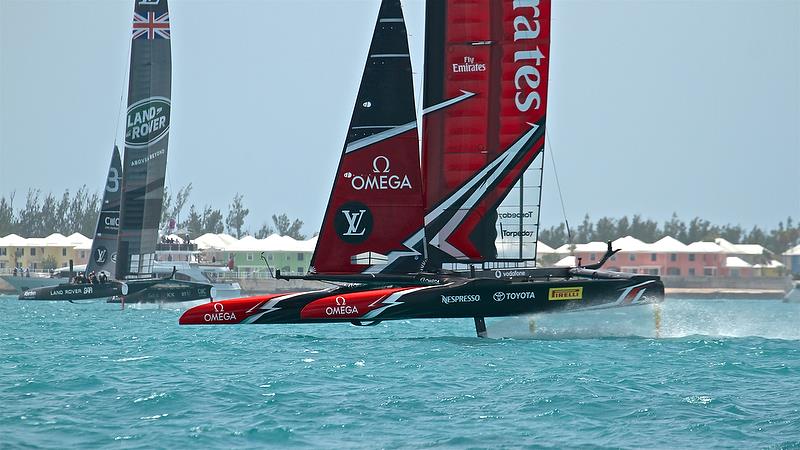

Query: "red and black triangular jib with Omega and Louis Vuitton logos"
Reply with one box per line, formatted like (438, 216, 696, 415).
(311, 0, 425, 274)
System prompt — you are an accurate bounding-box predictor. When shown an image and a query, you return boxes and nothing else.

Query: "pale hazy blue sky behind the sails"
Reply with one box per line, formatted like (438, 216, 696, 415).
(0, 0, 800, 234)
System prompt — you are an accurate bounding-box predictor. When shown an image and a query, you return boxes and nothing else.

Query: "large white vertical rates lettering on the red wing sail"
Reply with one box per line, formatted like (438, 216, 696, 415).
(506, 0, 545, 112)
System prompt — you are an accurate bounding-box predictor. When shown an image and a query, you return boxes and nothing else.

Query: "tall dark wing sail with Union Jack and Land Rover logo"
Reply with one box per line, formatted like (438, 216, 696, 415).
(116, 0, 172, 280)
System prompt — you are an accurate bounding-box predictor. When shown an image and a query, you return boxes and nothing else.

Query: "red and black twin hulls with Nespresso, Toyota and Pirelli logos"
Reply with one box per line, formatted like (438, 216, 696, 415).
(180, 276, 664, 325)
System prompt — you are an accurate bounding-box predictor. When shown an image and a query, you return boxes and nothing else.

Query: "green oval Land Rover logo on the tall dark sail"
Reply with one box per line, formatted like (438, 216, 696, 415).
(125, 97, 170, 148)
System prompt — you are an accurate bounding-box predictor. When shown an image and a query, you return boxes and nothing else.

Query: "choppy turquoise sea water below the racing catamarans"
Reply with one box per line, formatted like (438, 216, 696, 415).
(0, 296, 800, 449)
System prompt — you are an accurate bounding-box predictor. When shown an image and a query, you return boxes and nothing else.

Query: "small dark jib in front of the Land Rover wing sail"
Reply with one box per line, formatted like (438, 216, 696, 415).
(86, 145, 122, 276)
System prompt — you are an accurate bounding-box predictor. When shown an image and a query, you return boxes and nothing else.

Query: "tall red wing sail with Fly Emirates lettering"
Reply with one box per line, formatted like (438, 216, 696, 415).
(422, 0, 550, 266)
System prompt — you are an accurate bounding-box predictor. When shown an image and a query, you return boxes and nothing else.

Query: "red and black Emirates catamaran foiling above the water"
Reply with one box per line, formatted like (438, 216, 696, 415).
(180, 0, 664, 336)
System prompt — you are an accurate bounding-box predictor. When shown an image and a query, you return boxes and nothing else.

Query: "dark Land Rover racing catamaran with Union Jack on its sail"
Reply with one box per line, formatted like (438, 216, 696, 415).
(19, 0, 211, 303)
